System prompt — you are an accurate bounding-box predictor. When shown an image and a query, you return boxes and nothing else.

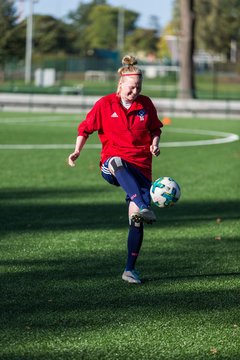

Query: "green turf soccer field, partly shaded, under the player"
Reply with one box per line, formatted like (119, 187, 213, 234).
(0, 113, 240, 360)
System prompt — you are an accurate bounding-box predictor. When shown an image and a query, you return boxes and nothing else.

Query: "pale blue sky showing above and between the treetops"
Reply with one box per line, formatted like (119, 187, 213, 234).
(15, 0, 173, 28)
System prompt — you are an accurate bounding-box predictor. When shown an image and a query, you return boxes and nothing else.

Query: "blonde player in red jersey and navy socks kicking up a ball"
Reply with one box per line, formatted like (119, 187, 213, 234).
(68, 55, 163, 284)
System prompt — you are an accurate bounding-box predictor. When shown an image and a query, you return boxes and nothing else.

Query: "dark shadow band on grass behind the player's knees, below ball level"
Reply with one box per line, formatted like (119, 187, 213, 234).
(0, 187, 240, 233)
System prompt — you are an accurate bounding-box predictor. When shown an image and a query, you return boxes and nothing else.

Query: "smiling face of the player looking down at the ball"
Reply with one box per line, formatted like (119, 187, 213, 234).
(119, 75, 142, 102)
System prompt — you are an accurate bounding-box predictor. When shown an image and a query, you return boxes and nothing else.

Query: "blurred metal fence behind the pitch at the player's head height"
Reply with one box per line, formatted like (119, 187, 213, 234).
(0, 57, 240, 100)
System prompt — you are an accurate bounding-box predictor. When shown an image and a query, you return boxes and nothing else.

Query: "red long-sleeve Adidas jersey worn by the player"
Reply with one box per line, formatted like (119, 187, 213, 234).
(78, 94, 163, 180)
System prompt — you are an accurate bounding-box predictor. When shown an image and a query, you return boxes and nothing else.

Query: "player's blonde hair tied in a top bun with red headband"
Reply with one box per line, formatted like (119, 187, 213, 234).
(117, 55, 142, 95)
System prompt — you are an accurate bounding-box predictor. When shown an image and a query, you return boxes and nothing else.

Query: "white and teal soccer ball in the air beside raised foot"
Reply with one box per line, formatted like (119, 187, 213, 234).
(150, 176, 181, 208)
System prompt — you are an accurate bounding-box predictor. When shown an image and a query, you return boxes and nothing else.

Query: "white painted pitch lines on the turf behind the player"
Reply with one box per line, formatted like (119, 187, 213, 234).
(0, 128, 239, 150)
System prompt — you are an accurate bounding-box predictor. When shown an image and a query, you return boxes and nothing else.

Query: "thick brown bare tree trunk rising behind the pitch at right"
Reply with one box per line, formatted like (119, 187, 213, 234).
(178, 0, 195, 99)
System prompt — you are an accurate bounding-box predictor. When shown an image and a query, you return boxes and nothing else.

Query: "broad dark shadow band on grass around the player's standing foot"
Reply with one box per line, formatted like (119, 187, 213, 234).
(0, 249, 240, 327)
